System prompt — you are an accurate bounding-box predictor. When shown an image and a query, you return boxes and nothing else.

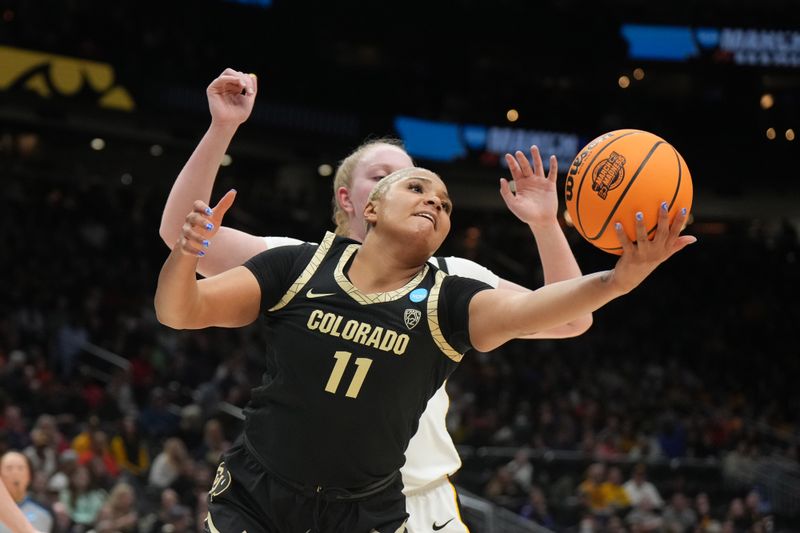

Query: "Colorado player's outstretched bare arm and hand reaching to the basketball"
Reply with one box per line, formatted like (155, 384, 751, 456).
(469, 204, 697, 351)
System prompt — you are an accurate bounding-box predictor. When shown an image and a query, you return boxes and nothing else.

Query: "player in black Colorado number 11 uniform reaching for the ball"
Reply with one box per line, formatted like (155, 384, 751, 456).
(155, 168, 695, 533)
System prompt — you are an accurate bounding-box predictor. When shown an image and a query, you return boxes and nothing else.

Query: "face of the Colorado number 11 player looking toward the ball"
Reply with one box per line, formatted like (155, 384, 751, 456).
(378, 170, 452, 254)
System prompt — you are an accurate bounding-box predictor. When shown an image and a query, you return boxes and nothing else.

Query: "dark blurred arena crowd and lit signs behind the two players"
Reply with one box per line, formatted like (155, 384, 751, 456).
(0, 0, 800, 533)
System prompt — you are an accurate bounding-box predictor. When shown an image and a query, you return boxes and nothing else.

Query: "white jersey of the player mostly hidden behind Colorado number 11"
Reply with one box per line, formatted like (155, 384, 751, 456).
(264, 237, 500, 493)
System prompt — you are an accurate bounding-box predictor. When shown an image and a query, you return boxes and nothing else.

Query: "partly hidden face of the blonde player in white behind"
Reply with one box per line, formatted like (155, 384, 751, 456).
(349, 144, 414, 240)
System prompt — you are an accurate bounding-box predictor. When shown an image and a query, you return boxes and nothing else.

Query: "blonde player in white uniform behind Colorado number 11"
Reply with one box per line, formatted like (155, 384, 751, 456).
(160, 69, 592, 533)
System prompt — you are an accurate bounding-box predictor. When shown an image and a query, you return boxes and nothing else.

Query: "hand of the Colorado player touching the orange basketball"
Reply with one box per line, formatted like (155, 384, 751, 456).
(612, 202, 697, 293)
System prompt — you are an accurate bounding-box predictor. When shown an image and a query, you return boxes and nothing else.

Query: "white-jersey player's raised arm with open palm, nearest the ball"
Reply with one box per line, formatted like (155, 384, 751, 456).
(498, 146, 592, 339)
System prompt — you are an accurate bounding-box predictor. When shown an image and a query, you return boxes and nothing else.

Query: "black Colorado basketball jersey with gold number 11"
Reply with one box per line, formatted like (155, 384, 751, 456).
(239, 233, 491, 488)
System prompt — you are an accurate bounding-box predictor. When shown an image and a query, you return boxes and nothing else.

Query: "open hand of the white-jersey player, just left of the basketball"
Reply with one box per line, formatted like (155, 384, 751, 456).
(500, 145, 558, 225)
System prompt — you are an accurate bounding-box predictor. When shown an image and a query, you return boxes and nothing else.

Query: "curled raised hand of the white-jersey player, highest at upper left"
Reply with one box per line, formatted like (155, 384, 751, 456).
(206, 68, 258, 126)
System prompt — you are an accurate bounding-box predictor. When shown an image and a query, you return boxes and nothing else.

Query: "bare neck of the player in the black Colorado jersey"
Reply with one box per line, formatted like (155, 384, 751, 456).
(347, 239, 425, 294)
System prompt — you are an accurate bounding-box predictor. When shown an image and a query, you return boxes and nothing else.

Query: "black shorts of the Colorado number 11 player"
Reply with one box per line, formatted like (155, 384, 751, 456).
(206, 439, 408, 533)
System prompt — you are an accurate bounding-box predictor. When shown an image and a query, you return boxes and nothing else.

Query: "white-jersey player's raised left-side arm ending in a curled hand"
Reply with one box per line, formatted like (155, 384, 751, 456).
(159, 69, 266, 276)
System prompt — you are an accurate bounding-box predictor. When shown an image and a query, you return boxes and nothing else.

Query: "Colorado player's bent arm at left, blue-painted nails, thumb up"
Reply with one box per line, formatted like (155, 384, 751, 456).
(155, 187, 261, 329)
